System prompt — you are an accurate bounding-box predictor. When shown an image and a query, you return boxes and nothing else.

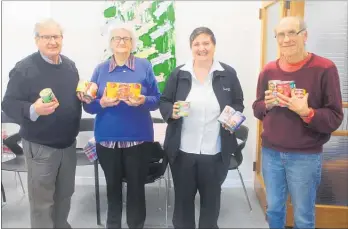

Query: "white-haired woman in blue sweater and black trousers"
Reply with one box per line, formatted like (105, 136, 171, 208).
(84, 25, 160, 228)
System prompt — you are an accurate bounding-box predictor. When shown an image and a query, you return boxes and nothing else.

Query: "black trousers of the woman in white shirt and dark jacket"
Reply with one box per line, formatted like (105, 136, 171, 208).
(171, 151, 228, 229)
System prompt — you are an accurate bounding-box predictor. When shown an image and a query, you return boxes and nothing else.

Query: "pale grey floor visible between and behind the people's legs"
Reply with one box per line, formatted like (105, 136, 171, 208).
(2, 167, 267, 228)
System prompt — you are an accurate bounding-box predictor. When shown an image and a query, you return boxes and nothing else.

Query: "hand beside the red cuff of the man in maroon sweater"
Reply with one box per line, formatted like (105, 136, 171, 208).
(277, 90, 310, 117)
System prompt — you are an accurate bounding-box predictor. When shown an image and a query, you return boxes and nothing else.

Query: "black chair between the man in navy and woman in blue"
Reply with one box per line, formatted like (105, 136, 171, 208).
(76, 118, 101, 225)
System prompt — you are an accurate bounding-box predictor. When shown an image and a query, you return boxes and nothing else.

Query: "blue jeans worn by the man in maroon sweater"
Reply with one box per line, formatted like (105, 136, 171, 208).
(262, 147, 322, 229)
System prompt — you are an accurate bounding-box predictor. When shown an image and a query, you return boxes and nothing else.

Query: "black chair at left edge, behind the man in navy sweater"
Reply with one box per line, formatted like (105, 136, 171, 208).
(1, 112, 28, 202)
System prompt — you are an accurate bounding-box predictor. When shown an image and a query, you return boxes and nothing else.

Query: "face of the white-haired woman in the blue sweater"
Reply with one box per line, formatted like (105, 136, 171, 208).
(110, 29, 133, 54)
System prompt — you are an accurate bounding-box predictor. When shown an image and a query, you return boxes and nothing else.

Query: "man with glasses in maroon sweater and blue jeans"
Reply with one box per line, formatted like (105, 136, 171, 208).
(253, 17, 343, 228)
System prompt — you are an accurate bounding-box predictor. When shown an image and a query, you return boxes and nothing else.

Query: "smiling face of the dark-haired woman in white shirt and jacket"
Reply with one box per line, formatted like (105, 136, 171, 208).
(191, 33, 215, 61)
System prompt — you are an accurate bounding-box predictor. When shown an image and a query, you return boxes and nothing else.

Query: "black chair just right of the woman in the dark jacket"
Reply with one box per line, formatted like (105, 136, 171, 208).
(228, 125, 252, 211)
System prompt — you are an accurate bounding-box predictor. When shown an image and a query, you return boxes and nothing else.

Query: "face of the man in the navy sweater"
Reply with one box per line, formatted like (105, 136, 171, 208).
(35, 24, 63, 57)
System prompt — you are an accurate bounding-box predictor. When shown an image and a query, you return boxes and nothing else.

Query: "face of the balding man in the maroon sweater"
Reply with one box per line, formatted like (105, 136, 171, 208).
(276, 18, 307, 57)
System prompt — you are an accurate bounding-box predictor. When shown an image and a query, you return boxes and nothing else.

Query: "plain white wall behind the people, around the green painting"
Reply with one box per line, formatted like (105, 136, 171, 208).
(2, 1, 261, 187)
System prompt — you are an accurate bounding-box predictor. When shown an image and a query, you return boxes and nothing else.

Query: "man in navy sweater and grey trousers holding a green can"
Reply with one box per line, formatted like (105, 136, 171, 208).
(2, 19, 82, 228)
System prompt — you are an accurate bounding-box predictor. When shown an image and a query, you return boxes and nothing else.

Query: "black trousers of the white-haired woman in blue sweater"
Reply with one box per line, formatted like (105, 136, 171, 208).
(96, 142, 151, 228)
